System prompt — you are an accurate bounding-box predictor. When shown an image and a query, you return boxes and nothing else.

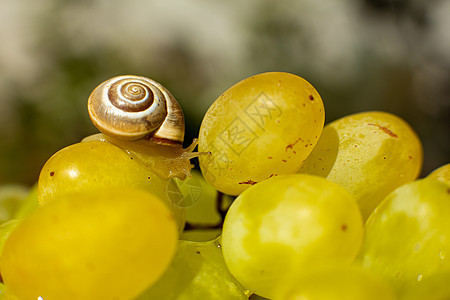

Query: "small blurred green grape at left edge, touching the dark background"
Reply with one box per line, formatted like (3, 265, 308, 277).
(0, 184, 28, 223)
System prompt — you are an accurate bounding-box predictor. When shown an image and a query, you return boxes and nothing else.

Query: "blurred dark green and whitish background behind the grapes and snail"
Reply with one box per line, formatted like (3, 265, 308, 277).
(0, 0, 450, 185)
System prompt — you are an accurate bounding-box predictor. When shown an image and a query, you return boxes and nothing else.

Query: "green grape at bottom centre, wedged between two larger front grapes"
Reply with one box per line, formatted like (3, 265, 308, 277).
(136, 240, 248, 300)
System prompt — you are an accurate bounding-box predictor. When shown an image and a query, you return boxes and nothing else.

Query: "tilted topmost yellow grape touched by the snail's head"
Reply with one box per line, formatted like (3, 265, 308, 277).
(199, 72, 325, 195)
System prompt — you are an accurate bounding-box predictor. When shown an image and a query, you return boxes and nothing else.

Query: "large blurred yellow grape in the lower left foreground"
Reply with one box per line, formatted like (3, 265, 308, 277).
(0, 188, 178, 300)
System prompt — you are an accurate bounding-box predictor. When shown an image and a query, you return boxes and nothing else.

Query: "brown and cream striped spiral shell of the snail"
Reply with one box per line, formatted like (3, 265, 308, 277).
(88, 75, 184, 144)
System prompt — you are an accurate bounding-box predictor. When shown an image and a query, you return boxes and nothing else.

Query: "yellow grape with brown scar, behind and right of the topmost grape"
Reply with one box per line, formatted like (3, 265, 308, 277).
(300, 112, 423, 219)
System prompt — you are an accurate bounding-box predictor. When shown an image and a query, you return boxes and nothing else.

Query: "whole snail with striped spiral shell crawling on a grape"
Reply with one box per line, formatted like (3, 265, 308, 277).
(83, 75, 206, 180)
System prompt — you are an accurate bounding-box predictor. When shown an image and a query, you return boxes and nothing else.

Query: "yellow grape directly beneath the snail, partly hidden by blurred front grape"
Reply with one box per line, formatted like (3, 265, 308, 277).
(38, 141, 184, 228)
